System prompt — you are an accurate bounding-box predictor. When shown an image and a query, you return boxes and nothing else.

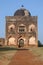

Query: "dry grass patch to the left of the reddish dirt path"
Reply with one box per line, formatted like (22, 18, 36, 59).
(0, 50, 17, 65)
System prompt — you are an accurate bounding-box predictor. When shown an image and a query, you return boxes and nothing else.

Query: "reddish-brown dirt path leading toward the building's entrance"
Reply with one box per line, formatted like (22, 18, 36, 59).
(9, 50, 43, 65)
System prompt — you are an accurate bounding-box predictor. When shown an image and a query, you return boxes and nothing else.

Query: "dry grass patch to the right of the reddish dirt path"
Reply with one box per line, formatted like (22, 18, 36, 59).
(30, 47, 43, 61)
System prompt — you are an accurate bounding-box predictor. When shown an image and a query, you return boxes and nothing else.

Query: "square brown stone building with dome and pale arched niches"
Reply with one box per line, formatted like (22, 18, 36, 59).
(5, 9, 38, 47)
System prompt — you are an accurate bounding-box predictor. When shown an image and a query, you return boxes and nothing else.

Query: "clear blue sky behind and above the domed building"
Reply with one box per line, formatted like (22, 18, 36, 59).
(0, 0, 43, 43)
